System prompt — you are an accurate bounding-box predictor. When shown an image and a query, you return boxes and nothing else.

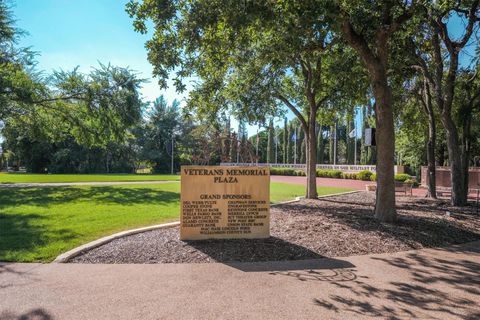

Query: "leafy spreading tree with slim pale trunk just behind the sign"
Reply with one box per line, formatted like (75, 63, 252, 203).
(127, 0, 364, 198)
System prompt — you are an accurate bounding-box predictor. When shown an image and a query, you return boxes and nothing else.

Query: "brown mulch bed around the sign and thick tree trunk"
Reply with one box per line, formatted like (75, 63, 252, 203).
(70, 192, 480, 263)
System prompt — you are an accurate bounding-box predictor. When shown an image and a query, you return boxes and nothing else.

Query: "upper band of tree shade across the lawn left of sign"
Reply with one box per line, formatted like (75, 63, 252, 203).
(0, 186, 180, 209)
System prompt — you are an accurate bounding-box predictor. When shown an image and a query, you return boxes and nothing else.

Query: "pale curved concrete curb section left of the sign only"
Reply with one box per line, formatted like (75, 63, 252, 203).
(52, 221, 180, 263)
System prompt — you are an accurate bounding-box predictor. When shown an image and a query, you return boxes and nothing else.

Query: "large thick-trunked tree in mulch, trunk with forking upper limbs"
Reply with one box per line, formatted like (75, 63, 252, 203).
(336, 0, 415, 222)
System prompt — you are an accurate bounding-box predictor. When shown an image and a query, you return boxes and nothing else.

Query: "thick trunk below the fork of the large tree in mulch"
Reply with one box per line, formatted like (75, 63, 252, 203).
(373, 72, 397, 222)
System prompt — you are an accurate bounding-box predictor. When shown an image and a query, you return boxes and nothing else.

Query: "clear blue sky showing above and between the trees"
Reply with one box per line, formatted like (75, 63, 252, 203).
(12, 0, 478, 136)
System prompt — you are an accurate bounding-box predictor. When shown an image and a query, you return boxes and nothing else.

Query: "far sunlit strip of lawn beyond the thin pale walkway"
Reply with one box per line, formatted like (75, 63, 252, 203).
(0, 172, 180, 183)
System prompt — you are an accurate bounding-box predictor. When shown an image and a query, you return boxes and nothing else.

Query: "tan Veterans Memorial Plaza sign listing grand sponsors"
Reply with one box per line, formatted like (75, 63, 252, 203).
(180, 166, 270, 240)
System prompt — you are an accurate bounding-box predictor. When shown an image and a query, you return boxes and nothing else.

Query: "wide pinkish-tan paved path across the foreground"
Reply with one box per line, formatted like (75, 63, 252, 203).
(0, 241, 480, 320)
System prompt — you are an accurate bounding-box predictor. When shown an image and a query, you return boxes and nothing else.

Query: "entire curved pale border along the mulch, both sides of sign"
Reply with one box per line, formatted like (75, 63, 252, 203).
(53, 190, 360, 263)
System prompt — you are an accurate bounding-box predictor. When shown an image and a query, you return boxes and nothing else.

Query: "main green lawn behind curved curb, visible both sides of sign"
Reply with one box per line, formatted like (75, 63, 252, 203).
(0, 182, 347, 262)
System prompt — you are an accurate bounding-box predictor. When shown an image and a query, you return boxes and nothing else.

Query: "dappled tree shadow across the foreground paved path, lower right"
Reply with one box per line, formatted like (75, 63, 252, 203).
(314, 244, 480, 319)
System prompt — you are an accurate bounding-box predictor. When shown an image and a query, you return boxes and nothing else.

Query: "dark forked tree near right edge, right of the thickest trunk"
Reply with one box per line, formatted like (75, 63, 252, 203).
(412, 0, 480, 206)
